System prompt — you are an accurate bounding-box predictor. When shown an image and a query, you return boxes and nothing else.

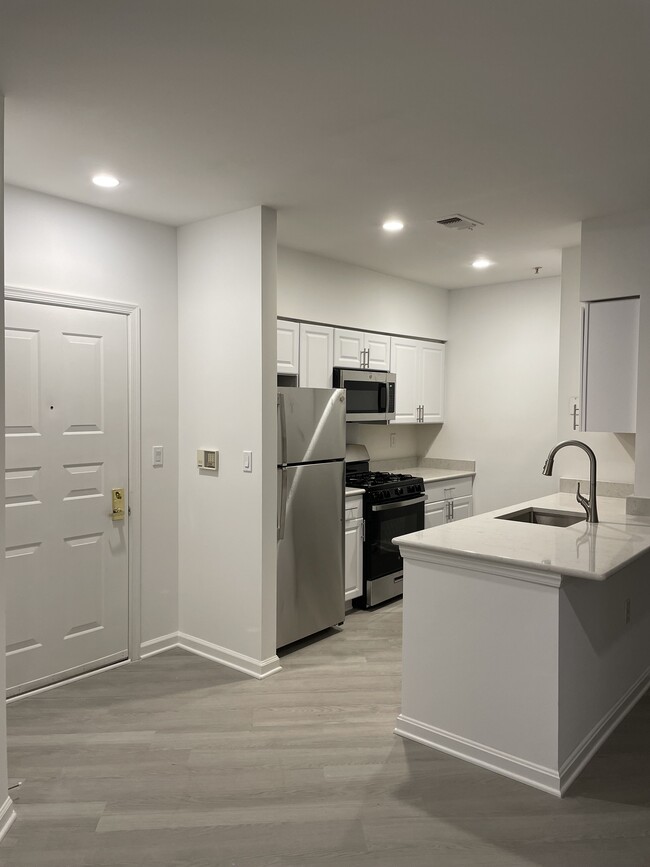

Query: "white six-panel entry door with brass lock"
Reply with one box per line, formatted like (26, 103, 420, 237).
(5, 301, 129, 695)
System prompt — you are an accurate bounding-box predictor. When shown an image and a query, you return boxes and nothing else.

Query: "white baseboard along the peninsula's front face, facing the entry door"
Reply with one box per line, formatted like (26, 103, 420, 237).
(395, 714, 562, 797)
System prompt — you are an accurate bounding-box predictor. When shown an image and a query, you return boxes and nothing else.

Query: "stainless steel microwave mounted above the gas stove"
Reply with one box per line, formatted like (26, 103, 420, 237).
(333, 367, 395, 424)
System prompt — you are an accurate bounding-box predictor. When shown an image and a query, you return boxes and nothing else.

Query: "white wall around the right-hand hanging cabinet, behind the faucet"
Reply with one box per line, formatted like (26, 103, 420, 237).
(554, 247, 635, 484)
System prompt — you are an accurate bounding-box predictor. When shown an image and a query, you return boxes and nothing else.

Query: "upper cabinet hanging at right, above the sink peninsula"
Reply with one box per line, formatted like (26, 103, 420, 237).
(580, 298, 639, 433)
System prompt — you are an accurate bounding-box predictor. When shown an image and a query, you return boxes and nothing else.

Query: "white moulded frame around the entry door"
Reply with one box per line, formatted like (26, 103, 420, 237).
(5, 286, 142, 662)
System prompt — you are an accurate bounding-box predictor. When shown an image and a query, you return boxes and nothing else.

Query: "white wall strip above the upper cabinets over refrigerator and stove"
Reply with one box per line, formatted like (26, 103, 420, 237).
(278, 247, 449, 340)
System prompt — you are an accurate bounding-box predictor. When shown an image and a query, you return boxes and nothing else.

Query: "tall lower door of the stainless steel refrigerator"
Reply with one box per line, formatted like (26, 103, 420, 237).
(276, 461, 345, 647)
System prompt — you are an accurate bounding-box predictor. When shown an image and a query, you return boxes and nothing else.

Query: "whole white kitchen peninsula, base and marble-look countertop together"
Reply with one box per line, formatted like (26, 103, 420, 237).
(395, 494, 650, 796)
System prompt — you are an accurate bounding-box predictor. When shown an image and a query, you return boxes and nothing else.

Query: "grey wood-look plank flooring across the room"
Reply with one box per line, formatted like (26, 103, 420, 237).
(0, 602, 650, 867)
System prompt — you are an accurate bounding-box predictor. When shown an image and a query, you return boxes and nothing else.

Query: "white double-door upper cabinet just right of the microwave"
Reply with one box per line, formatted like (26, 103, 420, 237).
(390, 337, 445, 424)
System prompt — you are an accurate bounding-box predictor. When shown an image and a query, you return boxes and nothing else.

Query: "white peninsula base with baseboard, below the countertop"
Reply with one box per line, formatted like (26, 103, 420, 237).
(395, 552, 650, 796)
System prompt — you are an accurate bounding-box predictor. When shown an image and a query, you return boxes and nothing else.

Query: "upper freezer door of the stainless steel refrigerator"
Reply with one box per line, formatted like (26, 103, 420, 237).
(278, 388, 345, 464)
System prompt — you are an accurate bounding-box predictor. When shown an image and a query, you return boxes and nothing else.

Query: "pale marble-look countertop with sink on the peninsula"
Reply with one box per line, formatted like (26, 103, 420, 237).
(393, 492, 650, 581)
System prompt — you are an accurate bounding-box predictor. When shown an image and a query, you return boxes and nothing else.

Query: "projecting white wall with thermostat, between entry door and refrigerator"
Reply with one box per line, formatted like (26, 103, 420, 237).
(178, 207, 276, 675)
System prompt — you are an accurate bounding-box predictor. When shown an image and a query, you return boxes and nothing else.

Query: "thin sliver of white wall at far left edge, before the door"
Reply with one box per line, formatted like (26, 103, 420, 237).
(0, 95, 9, 834)
